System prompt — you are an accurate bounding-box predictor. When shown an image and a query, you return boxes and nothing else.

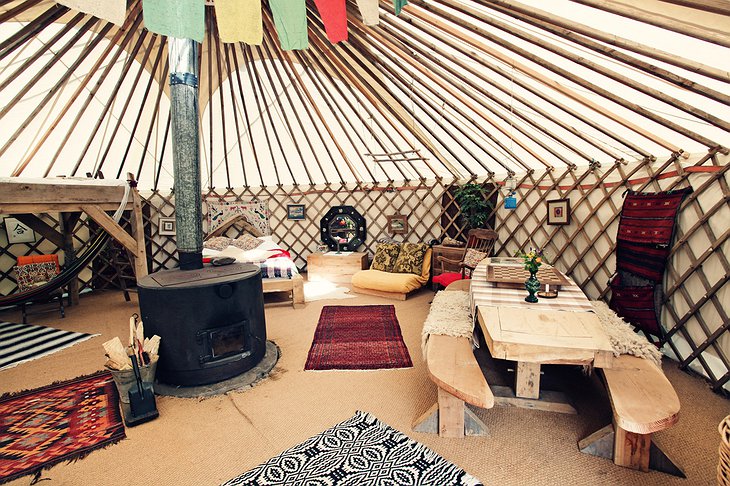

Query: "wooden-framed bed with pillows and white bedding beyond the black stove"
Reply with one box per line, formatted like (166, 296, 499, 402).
(203, 216, 304, 307)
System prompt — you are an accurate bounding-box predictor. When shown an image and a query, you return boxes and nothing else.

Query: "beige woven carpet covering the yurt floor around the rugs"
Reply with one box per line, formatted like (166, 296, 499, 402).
(0, 289, 730, 486)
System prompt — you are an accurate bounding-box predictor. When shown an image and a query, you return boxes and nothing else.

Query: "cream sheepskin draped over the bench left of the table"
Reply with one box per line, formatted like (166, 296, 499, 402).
(421, 290, 474, 359)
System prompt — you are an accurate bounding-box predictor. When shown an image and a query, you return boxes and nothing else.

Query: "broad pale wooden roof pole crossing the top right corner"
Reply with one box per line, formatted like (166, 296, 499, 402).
(572, 0, 730, 47)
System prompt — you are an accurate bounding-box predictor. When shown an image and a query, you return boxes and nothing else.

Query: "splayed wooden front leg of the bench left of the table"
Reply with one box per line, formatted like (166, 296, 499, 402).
(413, 388, 489, 438)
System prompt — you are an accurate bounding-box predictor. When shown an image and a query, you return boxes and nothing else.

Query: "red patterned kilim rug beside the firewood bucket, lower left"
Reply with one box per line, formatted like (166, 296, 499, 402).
(0, 371, 125, 483)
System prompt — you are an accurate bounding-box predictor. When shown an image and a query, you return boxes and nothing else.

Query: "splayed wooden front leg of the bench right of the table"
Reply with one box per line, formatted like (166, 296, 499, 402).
(578, 425, 686, 478)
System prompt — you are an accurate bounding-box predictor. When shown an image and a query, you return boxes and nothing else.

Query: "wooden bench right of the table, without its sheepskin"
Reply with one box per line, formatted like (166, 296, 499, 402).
(578, 355, 685, 477)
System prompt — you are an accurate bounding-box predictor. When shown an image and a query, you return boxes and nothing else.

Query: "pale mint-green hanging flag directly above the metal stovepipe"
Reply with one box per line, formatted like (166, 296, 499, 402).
(142, 0, 205, 42)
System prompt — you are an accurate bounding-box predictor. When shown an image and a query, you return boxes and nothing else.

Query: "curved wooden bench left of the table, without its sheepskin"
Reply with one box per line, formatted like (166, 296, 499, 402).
(413, 280, 494, 438)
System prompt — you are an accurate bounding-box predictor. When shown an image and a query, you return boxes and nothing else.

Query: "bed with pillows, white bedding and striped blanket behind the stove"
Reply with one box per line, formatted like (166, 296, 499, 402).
(203, 218, 304, 307)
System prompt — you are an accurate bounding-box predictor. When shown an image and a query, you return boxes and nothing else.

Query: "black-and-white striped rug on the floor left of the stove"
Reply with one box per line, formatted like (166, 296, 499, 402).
(0, 322, 98, 370)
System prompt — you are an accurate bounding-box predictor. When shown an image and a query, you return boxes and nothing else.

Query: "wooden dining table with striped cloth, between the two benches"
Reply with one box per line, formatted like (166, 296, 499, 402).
(471, 260, 613, 413)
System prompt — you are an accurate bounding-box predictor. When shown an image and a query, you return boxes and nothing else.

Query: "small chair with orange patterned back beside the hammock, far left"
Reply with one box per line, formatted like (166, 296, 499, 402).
(13, 255, 66, 324)
